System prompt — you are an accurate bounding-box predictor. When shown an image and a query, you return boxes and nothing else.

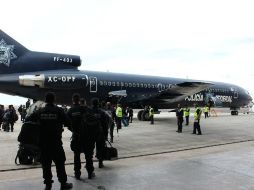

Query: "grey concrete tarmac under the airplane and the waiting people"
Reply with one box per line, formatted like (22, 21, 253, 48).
(0, 112, 254, 190)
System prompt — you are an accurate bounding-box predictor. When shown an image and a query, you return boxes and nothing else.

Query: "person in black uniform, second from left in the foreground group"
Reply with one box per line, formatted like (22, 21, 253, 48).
(67, 94, 95, 179)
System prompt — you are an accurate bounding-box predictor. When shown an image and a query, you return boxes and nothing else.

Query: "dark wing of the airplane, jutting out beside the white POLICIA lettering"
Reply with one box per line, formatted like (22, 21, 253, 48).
(157, 82, 213, 102)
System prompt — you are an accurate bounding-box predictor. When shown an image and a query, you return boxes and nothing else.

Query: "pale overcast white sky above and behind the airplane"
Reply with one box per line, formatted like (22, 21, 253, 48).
(0, 0, 254, 104)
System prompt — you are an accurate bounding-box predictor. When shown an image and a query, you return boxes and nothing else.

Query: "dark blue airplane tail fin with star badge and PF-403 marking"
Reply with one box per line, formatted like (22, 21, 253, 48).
(0, 30, 81, 74)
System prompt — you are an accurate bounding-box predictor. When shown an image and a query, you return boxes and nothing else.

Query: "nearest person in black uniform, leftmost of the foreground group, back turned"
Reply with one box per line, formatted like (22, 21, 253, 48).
(27, 92, 72, 190)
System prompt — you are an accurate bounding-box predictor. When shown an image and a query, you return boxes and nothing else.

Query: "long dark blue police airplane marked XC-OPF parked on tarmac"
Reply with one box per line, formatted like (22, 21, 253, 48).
(0, 30, 252, 120)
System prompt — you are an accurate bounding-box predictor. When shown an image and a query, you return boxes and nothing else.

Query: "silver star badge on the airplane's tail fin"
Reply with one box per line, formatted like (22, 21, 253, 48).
(0, 39, 17, 67)
